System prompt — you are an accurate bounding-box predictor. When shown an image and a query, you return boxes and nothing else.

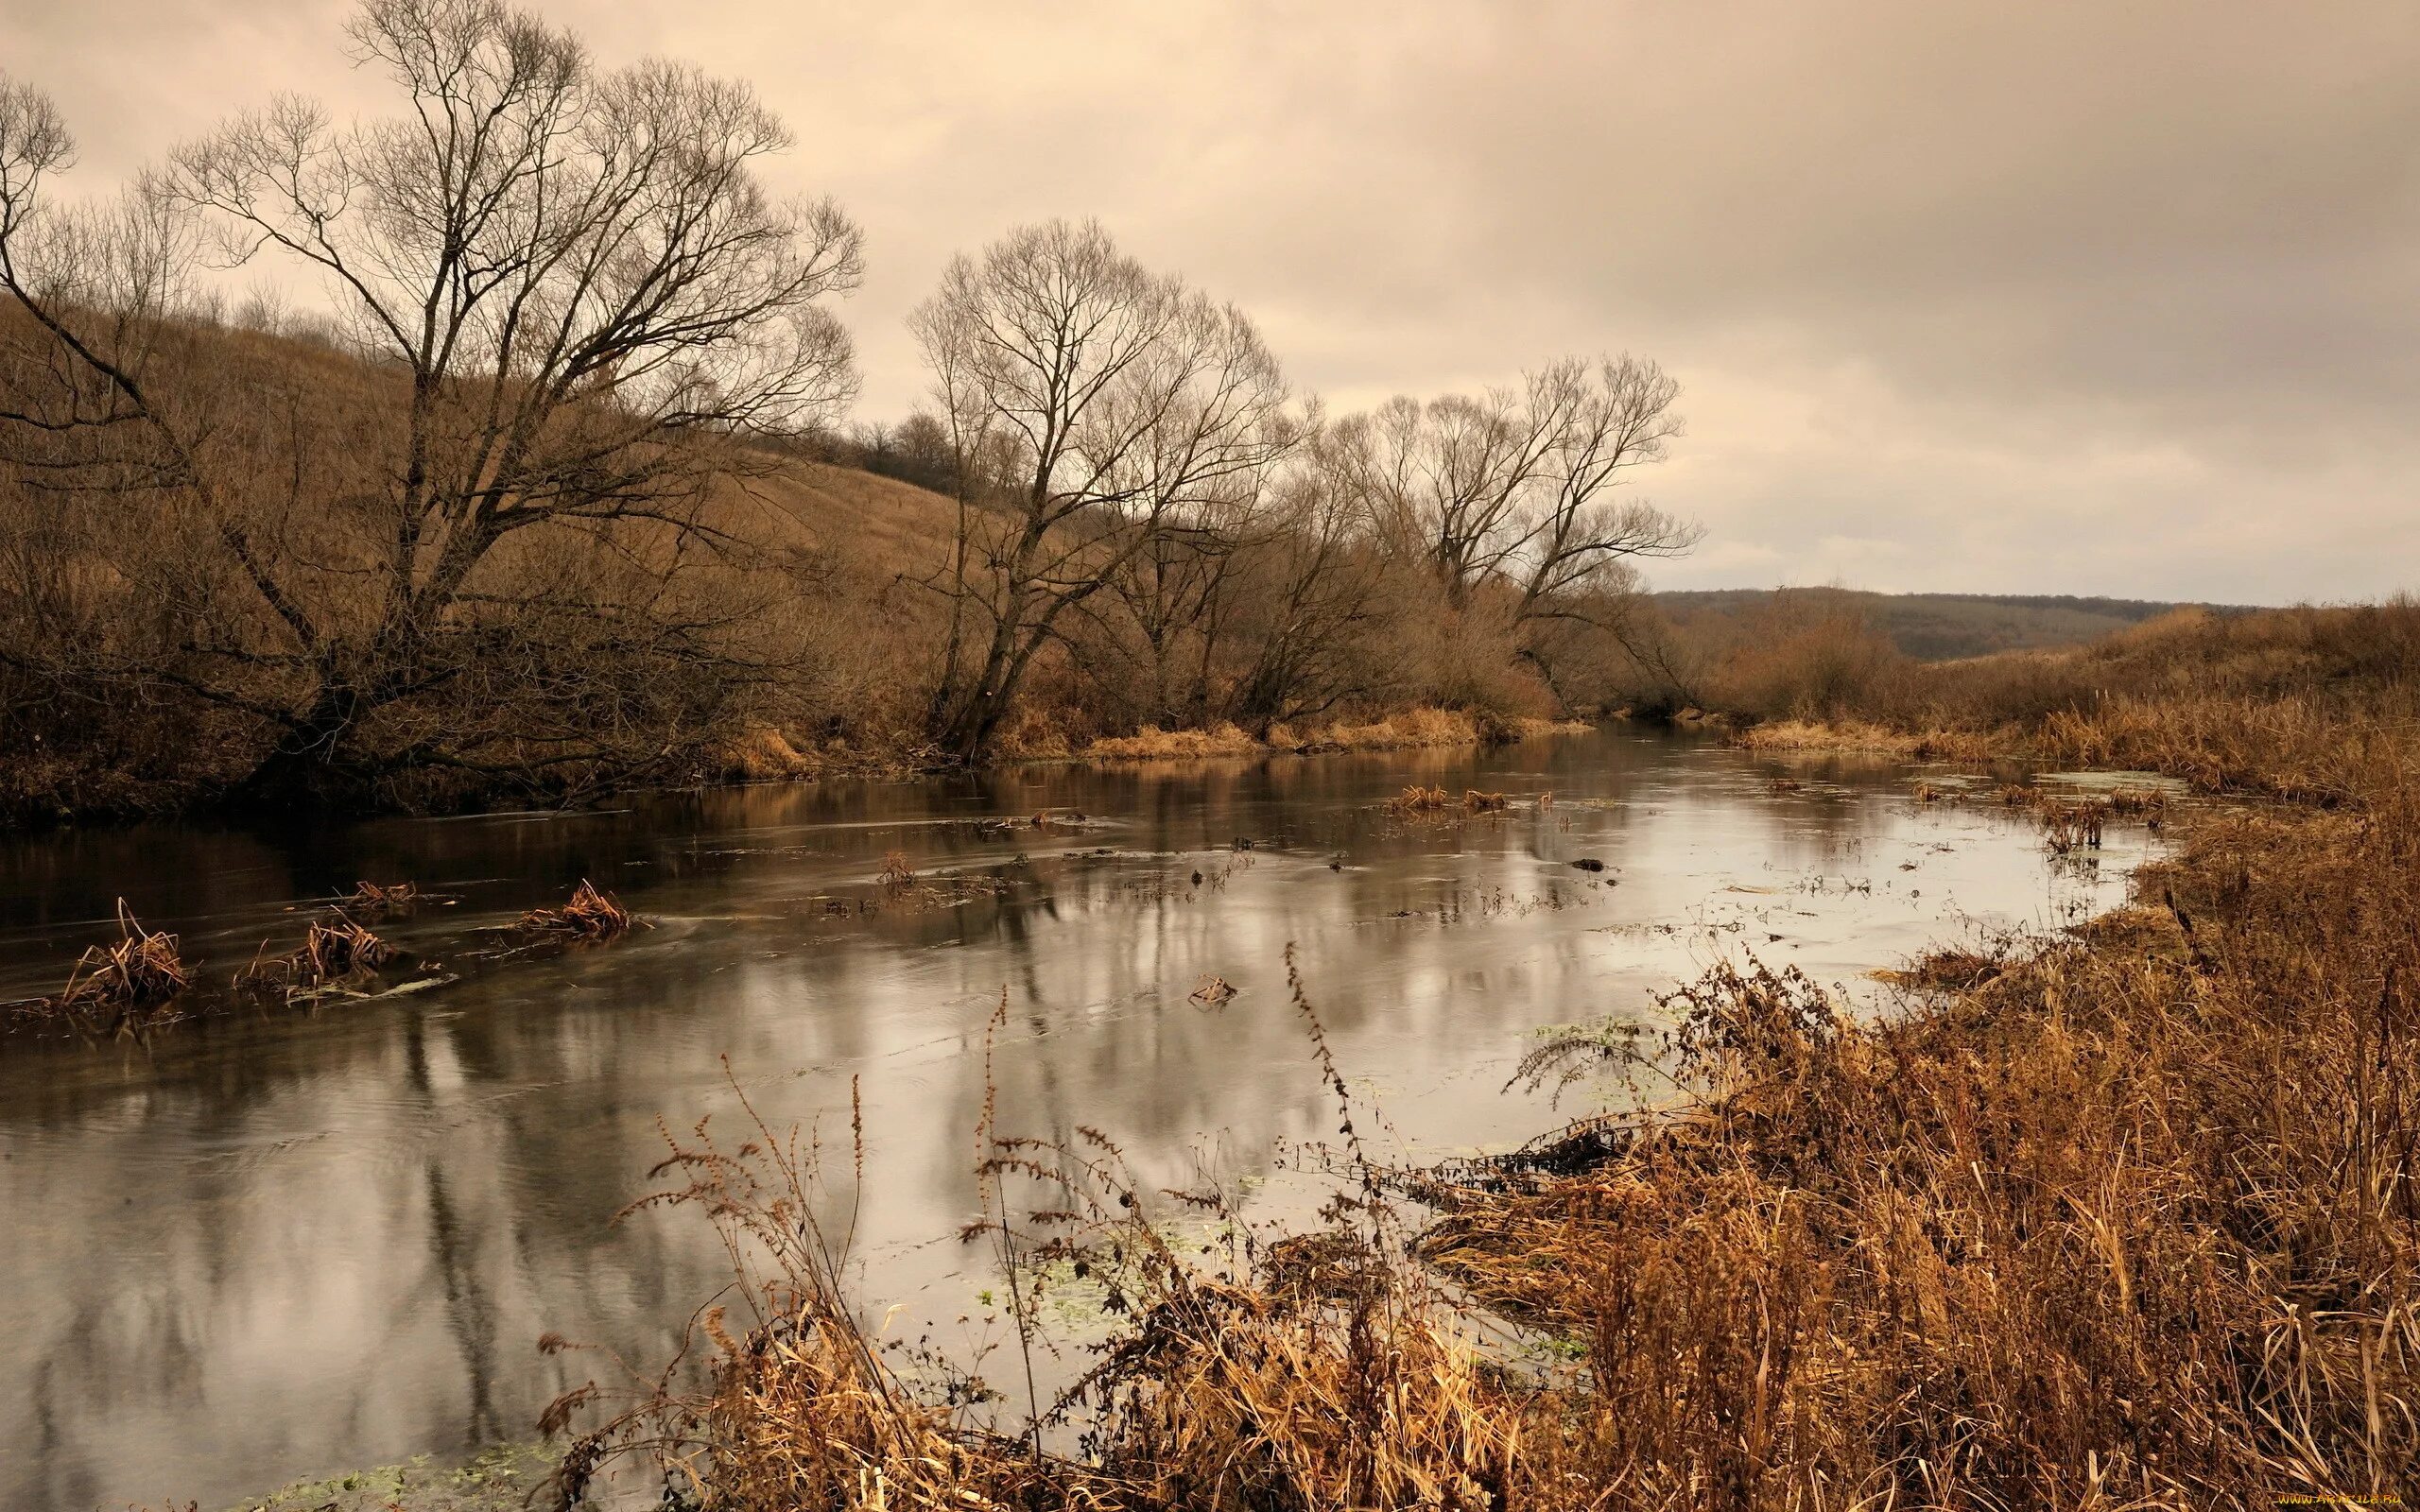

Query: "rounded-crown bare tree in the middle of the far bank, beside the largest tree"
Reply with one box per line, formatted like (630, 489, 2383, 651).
(912, 223, 1292, 760)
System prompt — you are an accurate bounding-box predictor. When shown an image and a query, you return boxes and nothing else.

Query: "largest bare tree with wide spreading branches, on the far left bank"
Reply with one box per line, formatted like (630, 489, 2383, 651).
(0, 0, 859, 802)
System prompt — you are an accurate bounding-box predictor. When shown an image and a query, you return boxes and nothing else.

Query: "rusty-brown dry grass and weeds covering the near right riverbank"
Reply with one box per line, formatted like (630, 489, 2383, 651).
(544, 624, 2420, 1512)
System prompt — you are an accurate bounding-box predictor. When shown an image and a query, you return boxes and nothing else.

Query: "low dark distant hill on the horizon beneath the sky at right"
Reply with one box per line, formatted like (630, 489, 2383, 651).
(1655, 588, 2243, 661)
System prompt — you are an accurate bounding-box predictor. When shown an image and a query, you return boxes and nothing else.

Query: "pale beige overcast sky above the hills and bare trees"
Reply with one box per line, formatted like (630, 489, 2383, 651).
(0, 0, 2420, 602)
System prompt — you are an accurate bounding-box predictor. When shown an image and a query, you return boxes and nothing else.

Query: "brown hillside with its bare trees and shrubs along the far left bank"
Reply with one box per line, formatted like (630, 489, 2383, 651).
(0, 0, 1697, 816)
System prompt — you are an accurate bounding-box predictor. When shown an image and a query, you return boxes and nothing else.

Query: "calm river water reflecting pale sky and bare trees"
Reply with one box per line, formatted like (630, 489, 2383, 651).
(0, 733, 2147, 1509)
